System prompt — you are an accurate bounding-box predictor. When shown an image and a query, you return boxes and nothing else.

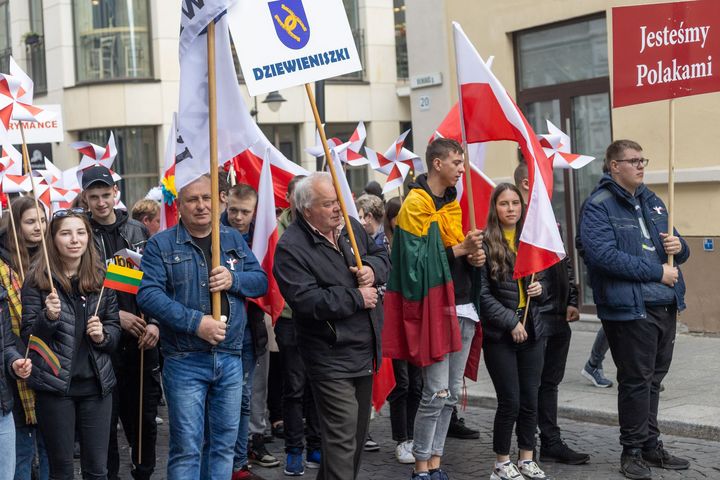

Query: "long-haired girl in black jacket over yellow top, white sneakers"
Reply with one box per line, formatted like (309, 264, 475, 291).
(480, 183, 546, 480)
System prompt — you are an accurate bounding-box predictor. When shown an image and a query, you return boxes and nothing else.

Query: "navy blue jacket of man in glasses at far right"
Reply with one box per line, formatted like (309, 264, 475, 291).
(577, 175, 690, 321)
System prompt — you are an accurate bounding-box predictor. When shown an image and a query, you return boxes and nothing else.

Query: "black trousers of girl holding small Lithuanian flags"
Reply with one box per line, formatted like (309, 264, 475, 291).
(35, 392, 112, 480)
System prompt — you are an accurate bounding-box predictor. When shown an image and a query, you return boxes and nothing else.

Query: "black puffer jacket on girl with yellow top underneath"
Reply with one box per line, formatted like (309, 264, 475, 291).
(478, 245, 547, 343)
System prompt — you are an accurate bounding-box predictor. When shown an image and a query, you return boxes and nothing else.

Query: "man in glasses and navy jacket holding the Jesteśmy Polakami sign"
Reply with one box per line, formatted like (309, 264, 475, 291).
(577, 140, 690, 479)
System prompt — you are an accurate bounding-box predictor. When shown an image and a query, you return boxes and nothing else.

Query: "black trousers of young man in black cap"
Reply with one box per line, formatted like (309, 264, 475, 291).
(108, 348, 162, 480)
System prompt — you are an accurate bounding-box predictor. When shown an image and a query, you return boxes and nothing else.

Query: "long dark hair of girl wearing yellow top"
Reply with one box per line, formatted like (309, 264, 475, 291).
(485, 183, 525, 282)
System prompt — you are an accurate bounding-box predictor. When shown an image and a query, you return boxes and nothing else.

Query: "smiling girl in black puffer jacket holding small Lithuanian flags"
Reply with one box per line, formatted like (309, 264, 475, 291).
(22, 209, 120, 480)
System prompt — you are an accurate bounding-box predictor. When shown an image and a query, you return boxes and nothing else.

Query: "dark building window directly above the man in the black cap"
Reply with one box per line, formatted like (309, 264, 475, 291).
(79, 127, 160, 209)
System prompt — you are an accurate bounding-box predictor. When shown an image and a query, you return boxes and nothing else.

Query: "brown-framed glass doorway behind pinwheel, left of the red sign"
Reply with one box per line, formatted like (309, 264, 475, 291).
(515, 15, 612, 313)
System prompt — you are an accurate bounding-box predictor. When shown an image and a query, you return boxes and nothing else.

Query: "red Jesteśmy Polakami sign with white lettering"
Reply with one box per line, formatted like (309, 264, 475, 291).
(612, 0, 720, 108)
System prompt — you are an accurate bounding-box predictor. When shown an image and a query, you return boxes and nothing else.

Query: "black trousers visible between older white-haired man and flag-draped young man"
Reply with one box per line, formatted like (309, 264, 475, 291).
(387, 360, 422, 443)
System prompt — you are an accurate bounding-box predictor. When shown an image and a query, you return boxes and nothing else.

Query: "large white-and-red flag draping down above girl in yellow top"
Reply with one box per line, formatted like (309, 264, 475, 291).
(453, 22, 565, 278)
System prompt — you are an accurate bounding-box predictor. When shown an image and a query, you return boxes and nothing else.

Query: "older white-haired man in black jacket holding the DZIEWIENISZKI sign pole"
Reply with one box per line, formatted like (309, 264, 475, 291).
(273, 173, 390, 480)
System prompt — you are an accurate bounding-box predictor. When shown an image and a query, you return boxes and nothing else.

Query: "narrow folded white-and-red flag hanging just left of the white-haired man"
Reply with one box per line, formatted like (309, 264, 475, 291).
(250, 148, 285, 325)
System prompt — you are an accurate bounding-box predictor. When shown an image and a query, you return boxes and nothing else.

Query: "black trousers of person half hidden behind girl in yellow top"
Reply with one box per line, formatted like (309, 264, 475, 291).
(538, 328, 572, 447)
